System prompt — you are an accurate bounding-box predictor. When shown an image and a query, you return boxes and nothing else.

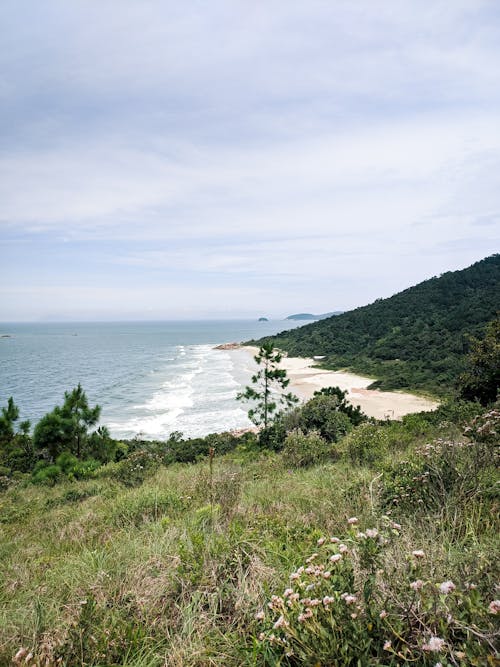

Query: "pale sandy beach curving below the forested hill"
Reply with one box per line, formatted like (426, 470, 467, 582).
(229, 347, 439, 419)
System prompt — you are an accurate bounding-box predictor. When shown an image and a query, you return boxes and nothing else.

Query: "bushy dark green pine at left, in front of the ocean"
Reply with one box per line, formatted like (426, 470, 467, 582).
(33, 384, 101, 460)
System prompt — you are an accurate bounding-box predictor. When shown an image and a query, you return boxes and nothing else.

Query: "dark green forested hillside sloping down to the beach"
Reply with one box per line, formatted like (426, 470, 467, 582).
(254, 254, 500, 393)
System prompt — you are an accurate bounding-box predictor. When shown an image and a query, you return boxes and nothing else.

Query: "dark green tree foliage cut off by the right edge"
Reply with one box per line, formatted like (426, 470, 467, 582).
(458, 317, 500, 405)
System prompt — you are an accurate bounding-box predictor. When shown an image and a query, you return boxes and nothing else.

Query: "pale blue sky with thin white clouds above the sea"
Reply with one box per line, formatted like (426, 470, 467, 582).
(0, 0, 500, 322)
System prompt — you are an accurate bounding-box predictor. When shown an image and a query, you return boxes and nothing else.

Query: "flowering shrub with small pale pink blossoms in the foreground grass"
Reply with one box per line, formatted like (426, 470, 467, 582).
(255, 517, 500, 667)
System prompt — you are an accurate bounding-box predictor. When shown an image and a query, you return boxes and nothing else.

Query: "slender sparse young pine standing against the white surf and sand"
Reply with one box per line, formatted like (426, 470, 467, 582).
(236, 342, 299, 429)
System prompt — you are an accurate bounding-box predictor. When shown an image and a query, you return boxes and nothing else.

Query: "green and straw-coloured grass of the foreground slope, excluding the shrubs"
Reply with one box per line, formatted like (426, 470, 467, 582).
(0, 414, 498, 667)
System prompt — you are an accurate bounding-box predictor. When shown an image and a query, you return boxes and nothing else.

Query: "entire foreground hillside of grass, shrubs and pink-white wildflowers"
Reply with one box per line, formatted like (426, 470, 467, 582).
(0, 380, 500, 667)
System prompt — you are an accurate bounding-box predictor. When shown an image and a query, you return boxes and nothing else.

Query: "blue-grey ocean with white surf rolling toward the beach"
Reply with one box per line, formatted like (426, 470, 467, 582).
(0, 320, 303, 439)
